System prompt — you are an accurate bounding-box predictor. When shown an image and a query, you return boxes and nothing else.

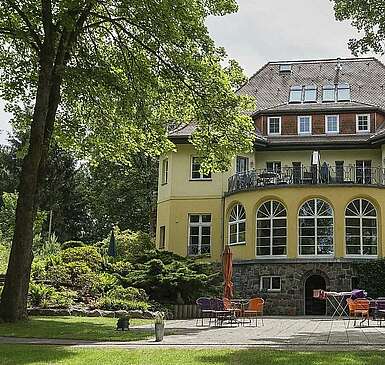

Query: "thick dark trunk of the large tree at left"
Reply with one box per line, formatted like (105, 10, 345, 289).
(0, 37, 55, 322)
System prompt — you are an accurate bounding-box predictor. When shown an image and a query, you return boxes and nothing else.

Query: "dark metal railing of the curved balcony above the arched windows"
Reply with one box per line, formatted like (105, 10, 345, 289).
(228, 165, 385, 193)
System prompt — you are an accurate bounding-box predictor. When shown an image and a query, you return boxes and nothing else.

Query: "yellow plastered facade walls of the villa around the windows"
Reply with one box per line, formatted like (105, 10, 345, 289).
(157, 144, 385, 261)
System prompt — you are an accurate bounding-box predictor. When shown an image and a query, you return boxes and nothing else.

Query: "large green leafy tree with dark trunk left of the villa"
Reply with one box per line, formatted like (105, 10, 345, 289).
(0, 0, 252, 321)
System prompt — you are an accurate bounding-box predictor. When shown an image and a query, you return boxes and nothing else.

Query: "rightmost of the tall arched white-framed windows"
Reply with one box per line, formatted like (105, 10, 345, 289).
(345, 199, 377, 255)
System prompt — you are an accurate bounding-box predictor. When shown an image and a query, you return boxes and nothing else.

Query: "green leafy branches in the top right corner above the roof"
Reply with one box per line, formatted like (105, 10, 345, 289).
(332, 0, 385, 56)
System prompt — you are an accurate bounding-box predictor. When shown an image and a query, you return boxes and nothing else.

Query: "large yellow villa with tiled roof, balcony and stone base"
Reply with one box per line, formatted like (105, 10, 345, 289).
(156, 58, 385, 314)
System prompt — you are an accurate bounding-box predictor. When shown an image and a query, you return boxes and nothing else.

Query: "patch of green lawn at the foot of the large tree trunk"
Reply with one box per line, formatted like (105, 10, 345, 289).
(0, 317, 153, 342)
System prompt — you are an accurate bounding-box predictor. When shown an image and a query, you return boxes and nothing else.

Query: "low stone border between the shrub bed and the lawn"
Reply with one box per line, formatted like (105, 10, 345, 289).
(28, 308, 155, 319)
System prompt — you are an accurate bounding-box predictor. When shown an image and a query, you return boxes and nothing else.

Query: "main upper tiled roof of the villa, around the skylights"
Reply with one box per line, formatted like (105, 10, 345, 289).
(238, 58, 385, 111)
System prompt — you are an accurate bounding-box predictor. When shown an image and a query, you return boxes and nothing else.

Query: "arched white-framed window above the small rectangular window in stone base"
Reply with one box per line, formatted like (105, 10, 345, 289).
(257, 200, 287, 256)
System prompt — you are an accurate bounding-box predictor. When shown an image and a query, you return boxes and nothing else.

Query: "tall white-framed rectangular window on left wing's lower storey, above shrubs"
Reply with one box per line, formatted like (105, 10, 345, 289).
(188, 214, 211, 256)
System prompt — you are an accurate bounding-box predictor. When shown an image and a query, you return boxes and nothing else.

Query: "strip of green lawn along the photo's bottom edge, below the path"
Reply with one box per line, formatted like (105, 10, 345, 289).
(0, 345, 385, 365)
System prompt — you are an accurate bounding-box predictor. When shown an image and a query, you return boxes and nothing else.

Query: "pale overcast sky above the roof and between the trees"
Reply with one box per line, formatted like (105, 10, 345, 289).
(0, 0, 385, 143)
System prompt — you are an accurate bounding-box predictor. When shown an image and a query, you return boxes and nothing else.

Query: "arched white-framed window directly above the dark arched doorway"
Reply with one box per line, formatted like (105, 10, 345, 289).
(298, 198, 333, 255)
